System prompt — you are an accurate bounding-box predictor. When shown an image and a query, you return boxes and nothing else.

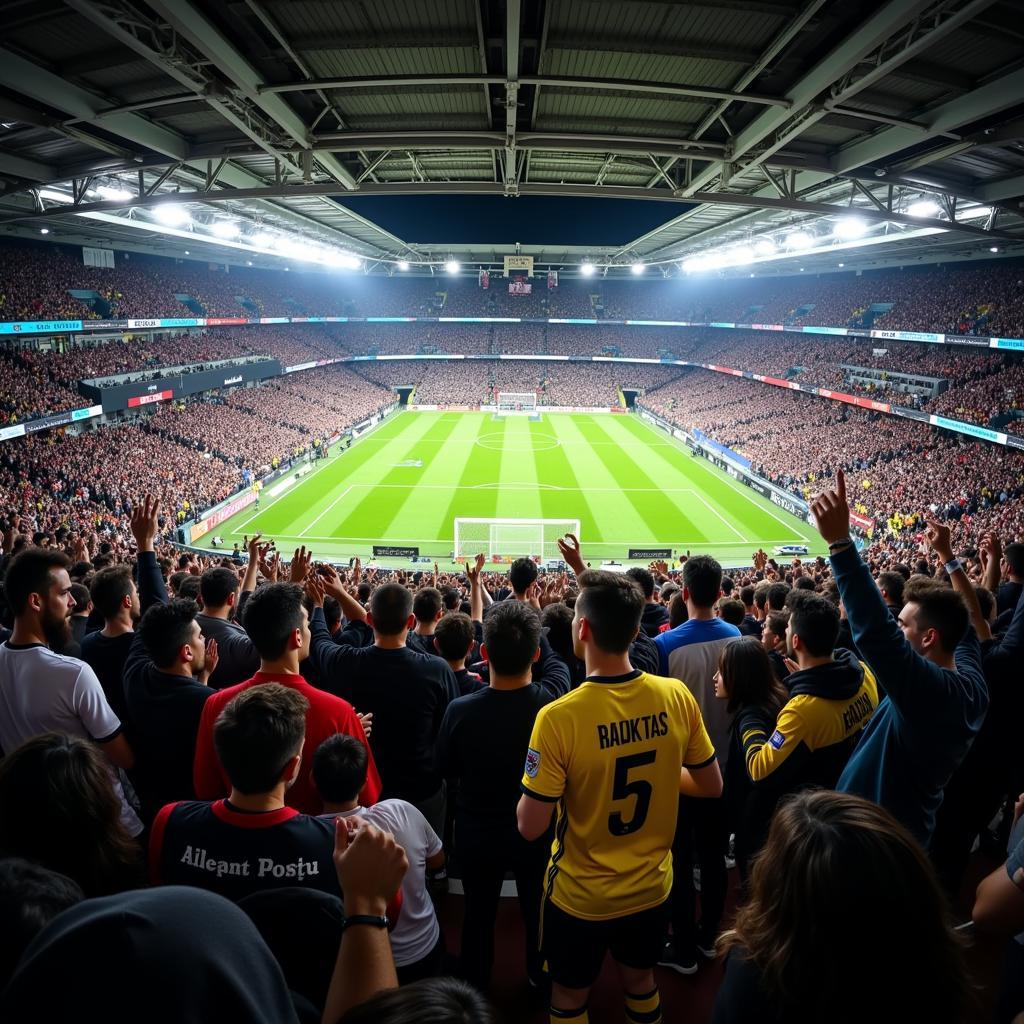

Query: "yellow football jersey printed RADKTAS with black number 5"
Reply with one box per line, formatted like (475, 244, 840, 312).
(522, 672, 715, 921)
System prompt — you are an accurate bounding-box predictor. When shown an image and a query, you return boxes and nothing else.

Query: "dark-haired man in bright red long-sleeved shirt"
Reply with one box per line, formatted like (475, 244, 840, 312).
(193, 583, 381, 814)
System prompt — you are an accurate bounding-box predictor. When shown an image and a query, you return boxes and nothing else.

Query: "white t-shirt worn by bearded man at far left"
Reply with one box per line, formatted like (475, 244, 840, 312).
(0, 643, 142, 836)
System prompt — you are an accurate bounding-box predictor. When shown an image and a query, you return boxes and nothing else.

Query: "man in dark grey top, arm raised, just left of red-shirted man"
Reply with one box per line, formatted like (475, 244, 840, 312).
(198, 561, 259, 690)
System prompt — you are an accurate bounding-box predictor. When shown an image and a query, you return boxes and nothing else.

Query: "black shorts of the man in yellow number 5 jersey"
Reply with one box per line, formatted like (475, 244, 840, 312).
(541, 899, 669, 988)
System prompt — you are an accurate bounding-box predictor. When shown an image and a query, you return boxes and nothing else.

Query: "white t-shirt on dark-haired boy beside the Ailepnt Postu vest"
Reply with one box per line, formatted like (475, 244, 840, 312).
(324, 800, 441, 967)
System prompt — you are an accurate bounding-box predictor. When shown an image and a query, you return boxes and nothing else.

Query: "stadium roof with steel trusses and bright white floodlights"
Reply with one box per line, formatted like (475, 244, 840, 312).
(0, 0, 1024, 272)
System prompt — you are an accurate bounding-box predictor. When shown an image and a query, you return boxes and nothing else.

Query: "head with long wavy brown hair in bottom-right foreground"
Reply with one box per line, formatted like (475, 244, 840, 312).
(724, 790, 968, 1024)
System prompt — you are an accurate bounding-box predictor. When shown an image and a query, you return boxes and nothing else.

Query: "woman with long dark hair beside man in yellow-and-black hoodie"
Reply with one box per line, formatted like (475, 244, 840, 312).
(715, 637, 788, 879)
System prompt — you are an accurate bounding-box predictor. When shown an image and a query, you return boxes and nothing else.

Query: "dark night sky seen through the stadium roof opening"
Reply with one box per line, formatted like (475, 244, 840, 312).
(334, 196, 693, 246)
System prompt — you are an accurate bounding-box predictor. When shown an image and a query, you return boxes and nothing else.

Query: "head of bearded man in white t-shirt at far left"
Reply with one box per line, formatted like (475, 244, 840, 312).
(4, 547, 75, 648)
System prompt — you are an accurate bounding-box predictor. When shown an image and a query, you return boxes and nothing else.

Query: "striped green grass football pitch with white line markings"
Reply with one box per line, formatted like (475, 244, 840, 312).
(215, 412, 824, 565)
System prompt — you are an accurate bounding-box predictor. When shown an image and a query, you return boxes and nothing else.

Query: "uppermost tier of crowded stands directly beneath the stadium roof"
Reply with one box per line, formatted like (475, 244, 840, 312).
(6, 242, 1024, 337)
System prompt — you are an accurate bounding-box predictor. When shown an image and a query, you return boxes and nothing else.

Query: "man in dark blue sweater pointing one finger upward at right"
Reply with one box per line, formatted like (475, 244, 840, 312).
(811, 469, 988, 847)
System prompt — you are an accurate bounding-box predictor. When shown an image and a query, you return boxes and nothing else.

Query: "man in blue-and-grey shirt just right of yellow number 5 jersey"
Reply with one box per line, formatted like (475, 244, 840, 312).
(654, 555, 739, 974)
